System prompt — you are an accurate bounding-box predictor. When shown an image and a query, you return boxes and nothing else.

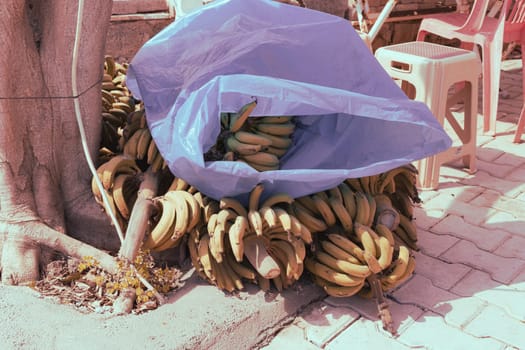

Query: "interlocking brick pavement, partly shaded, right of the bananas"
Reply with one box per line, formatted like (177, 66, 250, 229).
(263, 60, 525, 350)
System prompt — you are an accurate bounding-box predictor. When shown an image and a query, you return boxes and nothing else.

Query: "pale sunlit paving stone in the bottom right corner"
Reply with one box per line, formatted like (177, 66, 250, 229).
(465, 305, 525, 349)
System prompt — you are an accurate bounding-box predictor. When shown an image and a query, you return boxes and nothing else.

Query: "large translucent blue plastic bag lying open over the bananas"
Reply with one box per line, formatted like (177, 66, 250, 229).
(127, 0, 451, 199)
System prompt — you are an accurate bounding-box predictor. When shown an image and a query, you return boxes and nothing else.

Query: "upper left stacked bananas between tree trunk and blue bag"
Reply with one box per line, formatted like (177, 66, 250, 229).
(102, 56, 135, 151)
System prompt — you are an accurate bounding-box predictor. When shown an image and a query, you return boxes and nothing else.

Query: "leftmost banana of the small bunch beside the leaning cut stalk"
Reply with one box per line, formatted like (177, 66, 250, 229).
(142, 197, 175, 249)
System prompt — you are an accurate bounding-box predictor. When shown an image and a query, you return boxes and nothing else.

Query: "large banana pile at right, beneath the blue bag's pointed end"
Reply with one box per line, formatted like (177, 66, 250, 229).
(293, 166, 419, 297)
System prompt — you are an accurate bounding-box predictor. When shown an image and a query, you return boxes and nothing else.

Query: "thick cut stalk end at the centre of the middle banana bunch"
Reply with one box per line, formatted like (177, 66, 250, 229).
(244, 236, 281, 279)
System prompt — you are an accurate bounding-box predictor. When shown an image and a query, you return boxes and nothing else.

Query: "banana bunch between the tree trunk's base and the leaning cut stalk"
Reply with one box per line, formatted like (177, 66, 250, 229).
(91, 154, 141, 230)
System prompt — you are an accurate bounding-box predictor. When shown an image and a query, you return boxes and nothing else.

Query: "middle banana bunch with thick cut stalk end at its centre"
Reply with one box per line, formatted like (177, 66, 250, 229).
(189, 185, 312, 292)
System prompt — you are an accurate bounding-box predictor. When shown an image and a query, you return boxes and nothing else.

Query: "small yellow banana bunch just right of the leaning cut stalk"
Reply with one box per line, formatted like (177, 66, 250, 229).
(142, 190, 202, 251)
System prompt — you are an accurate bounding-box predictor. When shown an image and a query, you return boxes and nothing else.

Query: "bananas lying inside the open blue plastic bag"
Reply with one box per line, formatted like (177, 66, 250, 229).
(205, 101, 295, 171)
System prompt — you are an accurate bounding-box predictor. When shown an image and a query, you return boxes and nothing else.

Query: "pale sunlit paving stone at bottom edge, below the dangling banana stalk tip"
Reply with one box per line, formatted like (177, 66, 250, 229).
(325, 318, 410, 350)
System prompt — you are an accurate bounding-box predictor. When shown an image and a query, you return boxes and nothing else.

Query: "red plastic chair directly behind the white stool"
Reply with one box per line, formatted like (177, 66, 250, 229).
(417, 0, 508, 135)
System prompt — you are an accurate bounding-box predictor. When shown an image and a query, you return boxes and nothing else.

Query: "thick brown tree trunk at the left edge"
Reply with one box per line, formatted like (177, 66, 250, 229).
(0, 0, 119, 283)
